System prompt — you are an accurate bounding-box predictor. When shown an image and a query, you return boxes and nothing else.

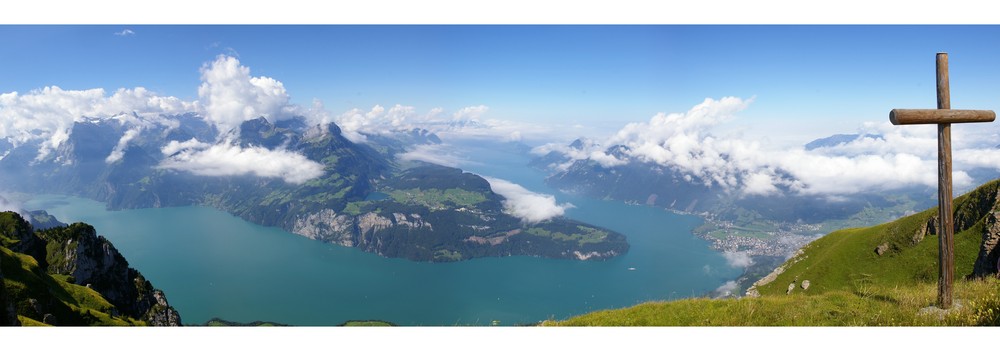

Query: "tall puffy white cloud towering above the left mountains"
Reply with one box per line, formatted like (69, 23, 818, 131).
(198, 55, 292, 131)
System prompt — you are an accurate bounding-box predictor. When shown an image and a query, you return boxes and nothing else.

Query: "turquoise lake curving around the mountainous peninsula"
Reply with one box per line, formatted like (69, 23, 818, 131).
(24, 141, 742, 326)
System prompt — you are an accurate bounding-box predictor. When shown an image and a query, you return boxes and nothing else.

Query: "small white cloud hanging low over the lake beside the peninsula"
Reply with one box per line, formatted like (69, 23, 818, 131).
(483, 177, 573, 223)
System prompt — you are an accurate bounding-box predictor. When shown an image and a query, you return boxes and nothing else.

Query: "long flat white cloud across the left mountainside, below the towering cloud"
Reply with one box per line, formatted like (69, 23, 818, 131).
(158, 139, 323, 184)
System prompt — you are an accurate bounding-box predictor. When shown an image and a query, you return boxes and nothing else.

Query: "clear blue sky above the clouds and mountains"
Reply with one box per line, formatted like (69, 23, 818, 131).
(0, 25, 1000, 144)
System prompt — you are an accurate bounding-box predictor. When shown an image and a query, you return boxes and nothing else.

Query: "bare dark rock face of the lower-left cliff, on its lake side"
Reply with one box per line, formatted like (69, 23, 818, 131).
(38, 223, 181, 326)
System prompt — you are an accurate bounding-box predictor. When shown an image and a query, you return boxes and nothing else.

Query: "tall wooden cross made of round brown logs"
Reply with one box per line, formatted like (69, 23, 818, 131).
(889, 52, 996, 309)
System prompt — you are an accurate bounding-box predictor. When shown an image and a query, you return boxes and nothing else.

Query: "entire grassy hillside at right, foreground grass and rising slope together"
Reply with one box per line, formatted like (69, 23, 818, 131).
(543, 181, 1000, 326)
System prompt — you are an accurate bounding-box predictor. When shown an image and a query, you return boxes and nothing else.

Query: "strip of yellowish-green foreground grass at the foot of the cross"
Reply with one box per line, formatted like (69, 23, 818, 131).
(542, 278, 1000, 326)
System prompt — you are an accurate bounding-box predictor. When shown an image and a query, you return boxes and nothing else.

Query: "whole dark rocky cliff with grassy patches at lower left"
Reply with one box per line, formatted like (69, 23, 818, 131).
(0, 212, 181, 326)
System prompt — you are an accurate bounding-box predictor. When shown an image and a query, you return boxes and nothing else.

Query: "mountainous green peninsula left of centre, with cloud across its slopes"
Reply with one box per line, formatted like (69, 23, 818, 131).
(0, 113, 628, 261)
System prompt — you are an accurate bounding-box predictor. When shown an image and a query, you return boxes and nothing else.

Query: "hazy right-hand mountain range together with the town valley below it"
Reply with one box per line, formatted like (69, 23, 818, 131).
(530, 134, 956, 278)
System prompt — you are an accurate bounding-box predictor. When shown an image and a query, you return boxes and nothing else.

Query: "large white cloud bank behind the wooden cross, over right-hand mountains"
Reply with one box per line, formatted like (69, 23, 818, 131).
(533, 97, 1000, 196)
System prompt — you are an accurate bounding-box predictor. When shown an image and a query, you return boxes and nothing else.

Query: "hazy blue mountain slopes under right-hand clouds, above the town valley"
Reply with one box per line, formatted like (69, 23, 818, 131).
(530, 135, 928, 223)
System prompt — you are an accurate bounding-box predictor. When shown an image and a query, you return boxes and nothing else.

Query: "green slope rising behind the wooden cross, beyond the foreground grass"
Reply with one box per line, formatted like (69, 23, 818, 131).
(756, 181, 1000, 296)
